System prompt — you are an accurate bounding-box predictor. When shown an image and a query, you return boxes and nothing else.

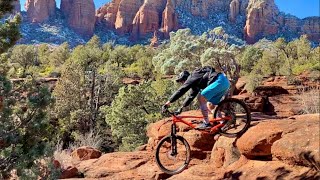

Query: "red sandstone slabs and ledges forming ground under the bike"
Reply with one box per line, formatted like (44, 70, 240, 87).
(53, 77, 320, 180)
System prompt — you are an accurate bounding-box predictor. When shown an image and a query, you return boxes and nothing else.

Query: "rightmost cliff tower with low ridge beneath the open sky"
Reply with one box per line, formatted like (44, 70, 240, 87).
(244, 0, 320, 43)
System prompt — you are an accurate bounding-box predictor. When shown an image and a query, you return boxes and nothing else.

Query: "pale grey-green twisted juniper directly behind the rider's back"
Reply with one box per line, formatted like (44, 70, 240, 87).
(153, 27, 242, 94)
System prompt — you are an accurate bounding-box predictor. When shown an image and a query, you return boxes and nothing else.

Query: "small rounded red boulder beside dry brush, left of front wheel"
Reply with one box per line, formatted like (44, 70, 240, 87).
(71, 146, 101, 161)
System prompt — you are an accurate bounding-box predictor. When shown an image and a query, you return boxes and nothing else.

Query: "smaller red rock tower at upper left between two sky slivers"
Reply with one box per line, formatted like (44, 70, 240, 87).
(25, 0, 56, 23)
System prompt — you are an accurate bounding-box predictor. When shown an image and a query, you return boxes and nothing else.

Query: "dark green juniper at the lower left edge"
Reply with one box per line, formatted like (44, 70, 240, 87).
(0, 77, 54, 179)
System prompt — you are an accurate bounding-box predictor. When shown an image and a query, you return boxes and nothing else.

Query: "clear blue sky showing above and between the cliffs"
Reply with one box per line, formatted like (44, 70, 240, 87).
(21, 0, 320, 18)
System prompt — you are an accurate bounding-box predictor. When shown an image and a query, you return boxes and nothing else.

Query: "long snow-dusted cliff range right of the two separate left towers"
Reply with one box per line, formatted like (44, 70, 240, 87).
(96, 0, 320, 43)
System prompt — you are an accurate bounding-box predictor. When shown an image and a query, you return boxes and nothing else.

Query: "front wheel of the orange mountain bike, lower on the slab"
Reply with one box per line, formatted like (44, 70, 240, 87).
(156, 135, 190, 175)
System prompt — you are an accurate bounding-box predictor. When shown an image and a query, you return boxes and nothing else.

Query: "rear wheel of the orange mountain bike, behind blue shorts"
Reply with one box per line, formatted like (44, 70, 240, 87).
(214, 98, 251, 137)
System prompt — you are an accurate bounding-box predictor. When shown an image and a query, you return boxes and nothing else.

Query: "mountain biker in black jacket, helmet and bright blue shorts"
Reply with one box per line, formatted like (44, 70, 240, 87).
(162, 66, 230, 129)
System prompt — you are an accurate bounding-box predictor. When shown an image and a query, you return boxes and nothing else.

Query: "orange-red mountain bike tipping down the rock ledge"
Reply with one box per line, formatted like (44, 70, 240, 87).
(155, 98, 251, 175)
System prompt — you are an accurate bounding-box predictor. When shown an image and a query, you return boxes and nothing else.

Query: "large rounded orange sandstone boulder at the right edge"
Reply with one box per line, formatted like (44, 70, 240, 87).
(271, 114, 320, 170)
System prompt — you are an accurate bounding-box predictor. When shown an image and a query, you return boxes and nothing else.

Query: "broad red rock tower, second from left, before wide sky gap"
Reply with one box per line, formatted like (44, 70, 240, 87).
(61, 0, 95, 36)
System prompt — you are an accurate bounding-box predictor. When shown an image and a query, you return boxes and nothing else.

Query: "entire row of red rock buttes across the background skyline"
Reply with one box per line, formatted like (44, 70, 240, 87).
(15, 0, 320, 43)
